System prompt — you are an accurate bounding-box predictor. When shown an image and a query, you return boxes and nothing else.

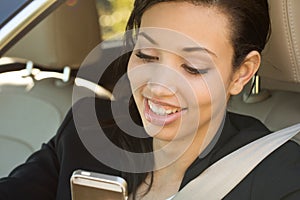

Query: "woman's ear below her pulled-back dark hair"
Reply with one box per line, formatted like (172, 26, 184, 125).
(229, 51, 261, 95)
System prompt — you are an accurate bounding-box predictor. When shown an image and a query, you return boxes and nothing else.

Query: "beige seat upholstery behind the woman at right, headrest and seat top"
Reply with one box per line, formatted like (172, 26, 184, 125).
(228, 0, 300, 141)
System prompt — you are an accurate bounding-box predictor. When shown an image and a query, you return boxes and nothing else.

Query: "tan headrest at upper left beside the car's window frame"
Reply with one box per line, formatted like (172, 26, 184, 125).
(5, 0, 101, 69)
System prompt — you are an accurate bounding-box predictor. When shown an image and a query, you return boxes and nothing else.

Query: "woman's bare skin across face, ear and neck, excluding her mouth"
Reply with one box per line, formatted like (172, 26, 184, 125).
(128, 2, 260, 199)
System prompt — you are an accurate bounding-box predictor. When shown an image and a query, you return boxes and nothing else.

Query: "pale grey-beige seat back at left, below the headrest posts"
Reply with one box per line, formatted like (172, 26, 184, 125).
(0, 76, 73, 177)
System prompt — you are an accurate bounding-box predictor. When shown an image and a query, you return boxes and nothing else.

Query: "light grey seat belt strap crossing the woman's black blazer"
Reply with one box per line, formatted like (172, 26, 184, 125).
(172, 123, 300, 200)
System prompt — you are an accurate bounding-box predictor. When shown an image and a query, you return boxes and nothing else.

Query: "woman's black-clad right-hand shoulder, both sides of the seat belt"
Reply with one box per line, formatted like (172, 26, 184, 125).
(217, 113, 300, 200)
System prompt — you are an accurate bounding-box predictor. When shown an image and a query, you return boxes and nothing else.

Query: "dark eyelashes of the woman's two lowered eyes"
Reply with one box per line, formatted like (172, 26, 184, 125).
(135, 51, 208, 75)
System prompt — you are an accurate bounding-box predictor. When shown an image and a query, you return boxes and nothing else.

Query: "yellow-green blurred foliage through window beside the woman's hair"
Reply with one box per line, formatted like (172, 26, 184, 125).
(97, 0, 134, 40)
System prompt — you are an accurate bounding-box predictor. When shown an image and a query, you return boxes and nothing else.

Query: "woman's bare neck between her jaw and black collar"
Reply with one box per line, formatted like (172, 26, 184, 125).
(153, 110, 225, 178)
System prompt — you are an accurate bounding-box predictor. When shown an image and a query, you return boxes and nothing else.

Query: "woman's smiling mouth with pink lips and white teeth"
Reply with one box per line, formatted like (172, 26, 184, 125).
(144, 99, 187, 126)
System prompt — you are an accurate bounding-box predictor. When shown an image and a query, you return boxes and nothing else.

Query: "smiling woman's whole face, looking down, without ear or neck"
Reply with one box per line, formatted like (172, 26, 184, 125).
(128, 2, 243, 145)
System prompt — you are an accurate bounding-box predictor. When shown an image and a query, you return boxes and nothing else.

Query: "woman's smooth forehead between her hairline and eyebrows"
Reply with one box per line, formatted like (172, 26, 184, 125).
(141, 2, 232, 58)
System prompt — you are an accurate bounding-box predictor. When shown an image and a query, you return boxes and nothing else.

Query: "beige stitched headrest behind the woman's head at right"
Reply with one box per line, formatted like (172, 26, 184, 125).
(259, 0, 300, 92)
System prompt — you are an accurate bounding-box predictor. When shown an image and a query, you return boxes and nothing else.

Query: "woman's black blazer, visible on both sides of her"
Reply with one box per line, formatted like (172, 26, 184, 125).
(0, 99, 300, 200)
